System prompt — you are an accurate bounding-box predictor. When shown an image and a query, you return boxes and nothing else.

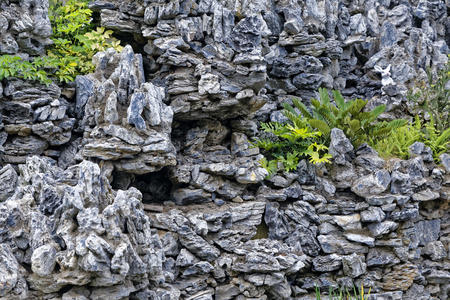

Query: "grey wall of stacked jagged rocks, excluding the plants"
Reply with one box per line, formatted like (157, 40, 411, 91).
(0, 0, 450, 300)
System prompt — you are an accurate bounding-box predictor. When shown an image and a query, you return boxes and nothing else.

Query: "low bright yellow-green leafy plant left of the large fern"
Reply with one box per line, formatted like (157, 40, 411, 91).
(253, 120, 331, 177)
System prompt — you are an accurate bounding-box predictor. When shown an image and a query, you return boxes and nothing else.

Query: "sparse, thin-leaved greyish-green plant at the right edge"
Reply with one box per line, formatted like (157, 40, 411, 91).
(407, 56, 450, 132)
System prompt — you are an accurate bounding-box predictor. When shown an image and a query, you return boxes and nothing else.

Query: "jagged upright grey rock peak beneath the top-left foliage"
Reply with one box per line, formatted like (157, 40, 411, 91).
(76, 46, 176, 174)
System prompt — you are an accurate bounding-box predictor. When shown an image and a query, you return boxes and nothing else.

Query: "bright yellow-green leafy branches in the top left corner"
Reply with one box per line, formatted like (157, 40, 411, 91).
(0, 0, 123, 85)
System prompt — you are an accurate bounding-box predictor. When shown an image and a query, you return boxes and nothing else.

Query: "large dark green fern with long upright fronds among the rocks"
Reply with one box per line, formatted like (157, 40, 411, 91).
(283, 88, 407, 147)
